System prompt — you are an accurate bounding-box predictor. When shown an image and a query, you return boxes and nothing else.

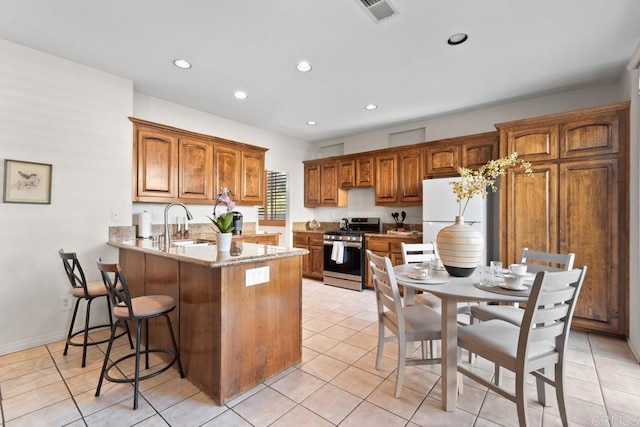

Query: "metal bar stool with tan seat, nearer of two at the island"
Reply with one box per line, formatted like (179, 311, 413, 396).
(96, 259, 184, 409)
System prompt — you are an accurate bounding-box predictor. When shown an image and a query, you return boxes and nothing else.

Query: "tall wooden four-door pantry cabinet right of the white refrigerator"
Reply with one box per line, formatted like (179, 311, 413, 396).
(496, 102, 629, 335)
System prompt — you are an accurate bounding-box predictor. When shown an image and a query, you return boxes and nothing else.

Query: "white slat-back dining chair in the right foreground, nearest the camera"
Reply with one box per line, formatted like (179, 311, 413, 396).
(458, 267, 587, 426)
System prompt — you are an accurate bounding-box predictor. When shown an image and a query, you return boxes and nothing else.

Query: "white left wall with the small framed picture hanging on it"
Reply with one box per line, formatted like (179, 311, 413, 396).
(0, 40, 133, 354)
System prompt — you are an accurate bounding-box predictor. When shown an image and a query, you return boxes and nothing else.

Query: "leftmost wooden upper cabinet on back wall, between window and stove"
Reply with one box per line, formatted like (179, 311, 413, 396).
(304, 158, 347, 207)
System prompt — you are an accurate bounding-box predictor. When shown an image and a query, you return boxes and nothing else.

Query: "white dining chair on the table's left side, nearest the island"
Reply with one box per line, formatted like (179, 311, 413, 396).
(367, 250, 442, 398)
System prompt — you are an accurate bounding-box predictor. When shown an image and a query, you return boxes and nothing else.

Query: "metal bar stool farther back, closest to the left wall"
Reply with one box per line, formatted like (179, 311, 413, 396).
(58, 249, 133, 368)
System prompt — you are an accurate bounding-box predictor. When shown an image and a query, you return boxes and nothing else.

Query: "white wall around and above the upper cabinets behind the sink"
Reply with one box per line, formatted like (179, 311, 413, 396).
(133, 92, 314, 246)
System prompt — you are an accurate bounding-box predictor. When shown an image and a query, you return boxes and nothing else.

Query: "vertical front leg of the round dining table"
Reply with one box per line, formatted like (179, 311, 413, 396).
(442, 298, 458, 411)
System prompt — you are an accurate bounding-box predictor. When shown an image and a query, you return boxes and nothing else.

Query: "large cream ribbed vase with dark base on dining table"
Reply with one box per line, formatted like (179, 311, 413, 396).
(436, 216, 484, 277)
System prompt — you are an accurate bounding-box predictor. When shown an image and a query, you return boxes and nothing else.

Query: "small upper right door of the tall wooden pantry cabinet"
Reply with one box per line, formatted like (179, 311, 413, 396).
(560, 112, 626, 158)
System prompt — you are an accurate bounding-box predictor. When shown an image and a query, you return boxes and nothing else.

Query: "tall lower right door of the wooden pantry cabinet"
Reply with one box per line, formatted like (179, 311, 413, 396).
(560, 159, 627, 333)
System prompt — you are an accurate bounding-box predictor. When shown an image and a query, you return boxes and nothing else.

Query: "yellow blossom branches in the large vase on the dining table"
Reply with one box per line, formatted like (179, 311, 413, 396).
(450, 153, 533, 216)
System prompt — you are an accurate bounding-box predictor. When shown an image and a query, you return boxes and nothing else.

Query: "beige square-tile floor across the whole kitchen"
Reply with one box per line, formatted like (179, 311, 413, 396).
(0, 280, 640, 427)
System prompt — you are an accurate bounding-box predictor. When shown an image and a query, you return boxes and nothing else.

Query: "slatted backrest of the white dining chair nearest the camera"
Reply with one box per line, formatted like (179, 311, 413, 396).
(517, 266, 587, 365)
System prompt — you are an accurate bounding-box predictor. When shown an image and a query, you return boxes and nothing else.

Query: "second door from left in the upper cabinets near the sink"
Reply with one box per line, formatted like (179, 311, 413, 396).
(178, 138, 213, 200)
